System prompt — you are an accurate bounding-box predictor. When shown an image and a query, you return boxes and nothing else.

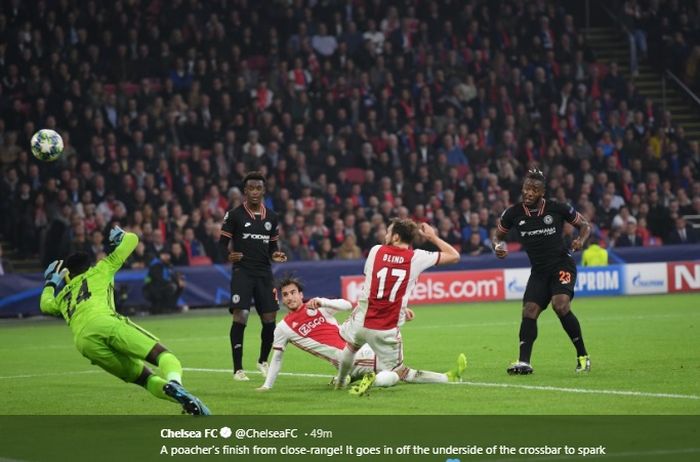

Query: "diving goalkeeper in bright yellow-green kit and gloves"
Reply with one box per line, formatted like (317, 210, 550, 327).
(41, 226, 210, 415)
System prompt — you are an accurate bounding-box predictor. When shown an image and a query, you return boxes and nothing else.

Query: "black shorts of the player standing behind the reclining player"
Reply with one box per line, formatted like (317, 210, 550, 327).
(229, 268, 280, 313)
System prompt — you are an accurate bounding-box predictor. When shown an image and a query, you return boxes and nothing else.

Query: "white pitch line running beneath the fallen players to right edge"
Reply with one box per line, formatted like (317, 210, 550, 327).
(183, 367, 700, 400)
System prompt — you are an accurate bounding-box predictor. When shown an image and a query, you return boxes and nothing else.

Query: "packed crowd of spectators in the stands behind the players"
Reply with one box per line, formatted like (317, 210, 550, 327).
(0, 0, 700, 268)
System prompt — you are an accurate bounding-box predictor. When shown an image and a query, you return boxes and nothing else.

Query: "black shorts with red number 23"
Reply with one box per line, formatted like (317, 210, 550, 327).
(523, 258, 576, 310)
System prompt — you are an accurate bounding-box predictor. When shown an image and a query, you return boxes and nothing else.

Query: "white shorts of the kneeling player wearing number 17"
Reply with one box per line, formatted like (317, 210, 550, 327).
(340, 318, 403, 372)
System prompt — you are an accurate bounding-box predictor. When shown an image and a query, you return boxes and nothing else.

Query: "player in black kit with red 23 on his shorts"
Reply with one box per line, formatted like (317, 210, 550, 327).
(492, 169, 591, 374)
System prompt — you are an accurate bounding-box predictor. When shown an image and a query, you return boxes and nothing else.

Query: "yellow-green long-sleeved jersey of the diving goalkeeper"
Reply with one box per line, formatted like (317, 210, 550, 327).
(41, 233, 139, 336)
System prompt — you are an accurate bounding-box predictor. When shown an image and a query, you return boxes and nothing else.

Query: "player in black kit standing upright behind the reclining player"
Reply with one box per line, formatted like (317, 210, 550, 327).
(219, 172, 287, 381)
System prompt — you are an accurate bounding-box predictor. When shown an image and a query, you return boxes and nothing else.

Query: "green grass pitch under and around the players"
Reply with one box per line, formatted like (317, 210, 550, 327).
(0, 294, 700, 415)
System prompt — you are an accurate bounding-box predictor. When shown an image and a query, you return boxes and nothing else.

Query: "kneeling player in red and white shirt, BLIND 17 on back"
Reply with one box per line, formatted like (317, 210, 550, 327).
(336, 219, 459, 388)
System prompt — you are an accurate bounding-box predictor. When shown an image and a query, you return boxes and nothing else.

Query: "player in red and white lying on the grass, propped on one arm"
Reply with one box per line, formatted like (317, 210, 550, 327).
(258, 277, 467, 393)
